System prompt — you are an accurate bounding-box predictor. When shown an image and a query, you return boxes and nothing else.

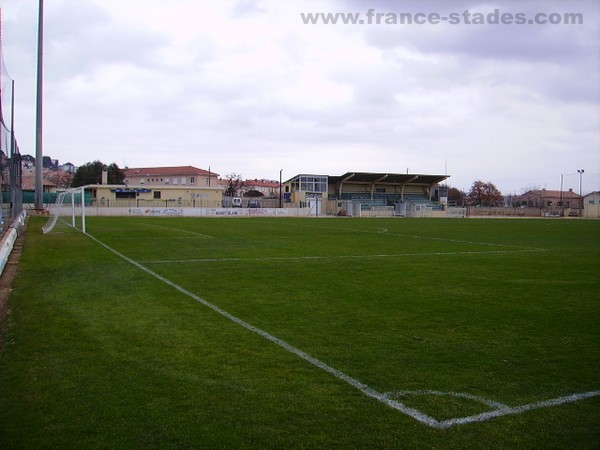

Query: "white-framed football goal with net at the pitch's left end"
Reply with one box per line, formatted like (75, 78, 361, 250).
(42, 186, 85, 233)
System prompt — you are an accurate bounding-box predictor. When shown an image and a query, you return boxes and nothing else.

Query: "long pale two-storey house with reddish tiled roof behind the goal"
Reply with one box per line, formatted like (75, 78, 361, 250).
(124, 166, 219, 187)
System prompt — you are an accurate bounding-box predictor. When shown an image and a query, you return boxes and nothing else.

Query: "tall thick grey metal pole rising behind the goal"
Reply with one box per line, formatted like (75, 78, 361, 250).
(34, 0, 44, 209)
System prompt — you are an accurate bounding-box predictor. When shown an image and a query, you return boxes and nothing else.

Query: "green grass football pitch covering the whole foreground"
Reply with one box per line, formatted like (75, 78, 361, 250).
(0, 218, 600, 448)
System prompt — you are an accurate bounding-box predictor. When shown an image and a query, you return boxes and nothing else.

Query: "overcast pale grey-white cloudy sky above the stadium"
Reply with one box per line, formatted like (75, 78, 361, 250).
(0, 0, 600, 194)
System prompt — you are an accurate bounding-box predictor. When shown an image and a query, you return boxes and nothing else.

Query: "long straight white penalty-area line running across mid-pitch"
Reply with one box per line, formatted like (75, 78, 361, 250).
(140, 249, 545, 264)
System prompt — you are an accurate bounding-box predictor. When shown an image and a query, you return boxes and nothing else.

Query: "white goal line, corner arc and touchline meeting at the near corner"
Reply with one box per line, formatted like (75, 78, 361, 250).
(84, 233, 600, 429)
